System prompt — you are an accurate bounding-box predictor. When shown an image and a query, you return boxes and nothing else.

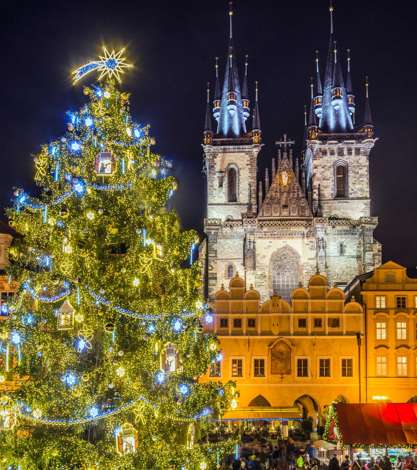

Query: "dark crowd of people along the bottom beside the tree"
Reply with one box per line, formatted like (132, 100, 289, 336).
(223, 441, 417, 470)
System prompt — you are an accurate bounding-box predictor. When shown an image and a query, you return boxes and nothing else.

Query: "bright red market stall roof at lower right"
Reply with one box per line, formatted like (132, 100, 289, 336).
(335, 403, 417, 446)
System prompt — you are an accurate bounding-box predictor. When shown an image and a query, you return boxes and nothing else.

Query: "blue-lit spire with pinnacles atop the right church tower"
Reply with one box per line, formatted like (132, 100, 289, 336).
(307, 0, 373, 140)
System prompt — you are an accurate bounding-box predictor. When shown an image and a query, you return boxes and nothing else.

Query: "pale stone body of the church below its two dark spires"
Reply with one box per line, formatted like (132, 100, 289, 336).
(204, 134, 381, 299)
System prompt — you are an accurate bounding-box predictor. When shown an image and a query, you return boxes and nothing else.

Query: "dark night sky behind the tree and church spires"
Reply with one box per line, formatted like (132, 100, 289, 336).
(0, 0, 417, 267)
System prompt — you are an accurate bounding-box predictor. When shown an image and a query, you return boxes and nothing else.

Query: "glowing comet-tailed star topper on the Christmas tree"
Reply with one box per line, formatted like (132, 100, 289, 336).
(72, 46, 133, 85)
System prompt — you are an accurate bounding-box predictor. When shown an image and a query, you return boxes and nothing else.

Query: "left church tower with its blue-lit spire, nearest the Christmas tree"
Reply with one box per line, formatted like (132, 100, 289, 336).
(203, 2, 262, 298)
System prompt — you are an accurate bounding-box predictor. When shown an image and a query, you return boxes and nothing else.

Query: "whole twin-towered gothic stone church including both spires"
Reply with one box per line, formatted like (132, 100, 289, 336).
(201, 2, 381, 300)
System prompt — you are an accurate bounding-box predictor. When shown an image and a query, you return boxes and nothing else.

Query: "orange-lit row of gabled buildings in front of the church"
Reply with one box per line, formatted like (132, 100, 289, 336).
(201, 261, 417, 424)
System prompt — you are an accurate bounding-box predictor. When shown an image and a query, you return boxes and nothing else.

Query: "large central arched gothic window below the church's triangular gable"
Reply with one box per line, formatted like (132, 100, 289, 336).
(270, 246, 300, 300)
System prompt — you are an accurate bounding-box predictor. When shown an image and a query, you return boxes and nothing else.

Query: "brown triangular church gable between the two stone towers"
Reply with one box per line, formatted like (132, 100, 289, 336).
(258, 154, 312, 218)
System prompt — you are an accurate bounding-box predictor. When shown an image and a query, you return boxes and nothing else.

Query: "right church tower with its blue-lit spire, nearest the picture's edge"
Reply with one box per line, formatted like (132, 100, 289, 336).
(304, 1, 381, 284)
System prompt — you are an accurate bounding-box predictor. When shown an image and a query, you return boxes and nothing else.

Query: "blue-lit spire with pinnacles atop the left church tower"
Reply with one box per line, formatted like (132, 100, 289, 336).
(204, 2, 261, 144)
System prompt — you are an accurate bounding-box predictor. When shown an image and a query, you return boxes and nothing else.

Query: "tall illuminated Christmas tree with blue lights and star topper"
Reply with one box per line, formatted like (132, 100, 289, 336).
(0, 51, 233, 470)
